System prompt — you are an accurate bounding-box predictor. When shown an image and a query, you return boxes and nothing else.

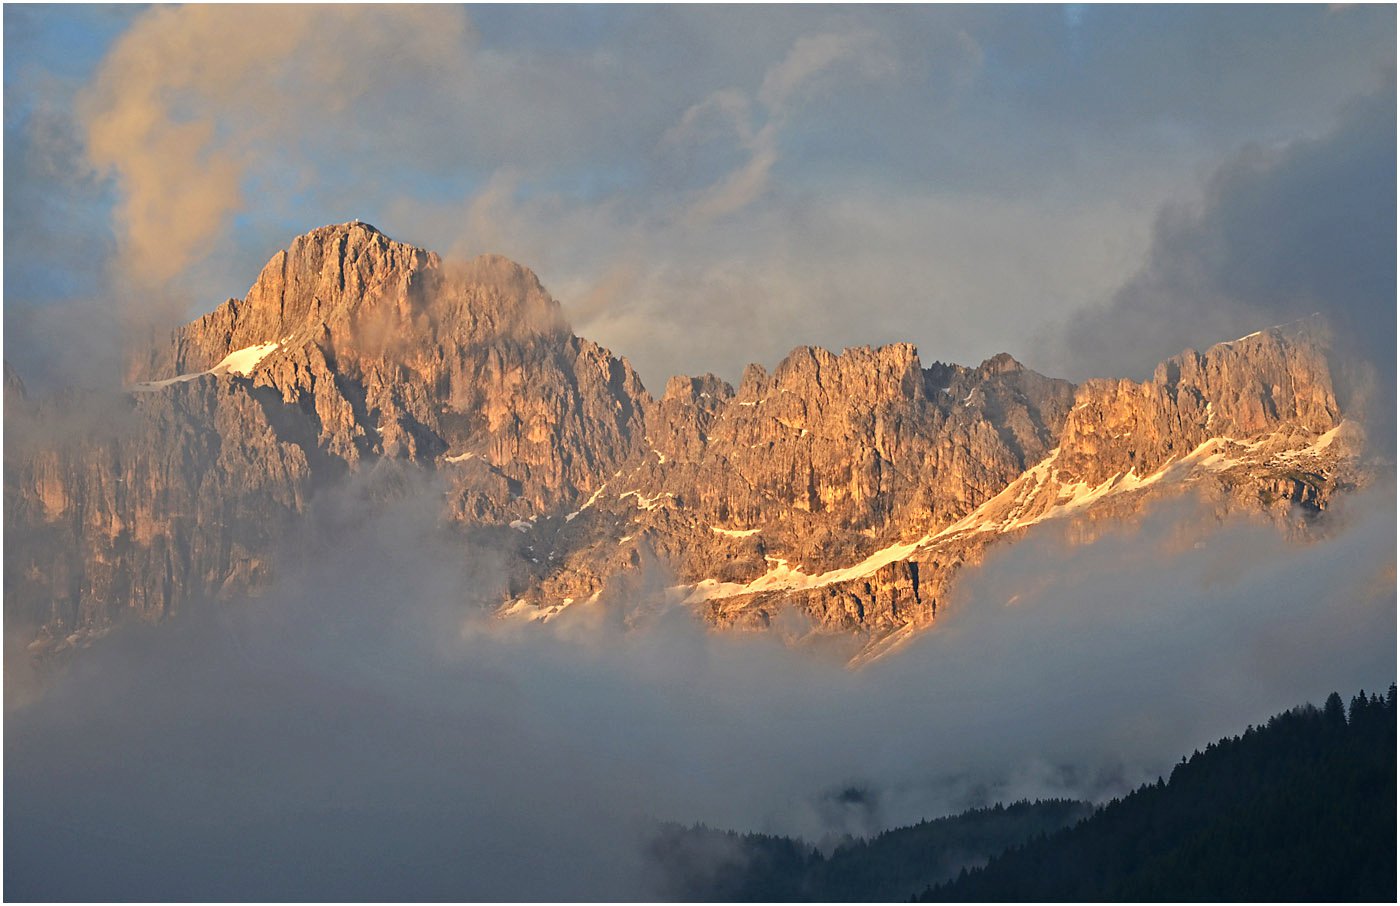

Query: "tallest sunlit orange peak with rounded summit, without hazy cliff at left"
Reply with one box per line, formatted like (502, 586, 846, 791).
(129, 223, 645, 509)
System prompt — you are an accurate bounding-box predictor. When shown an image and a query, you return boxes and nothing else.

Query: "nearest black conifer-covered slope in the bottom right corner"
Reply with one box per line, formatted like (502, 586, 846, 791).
(923, 685, 1396, 902)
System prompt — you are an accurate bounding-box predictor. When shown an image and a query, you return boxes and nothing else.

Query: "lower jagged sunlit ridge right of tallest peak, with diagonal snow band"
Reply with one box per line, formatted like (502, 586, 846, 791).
(507, 315, 1364, 657)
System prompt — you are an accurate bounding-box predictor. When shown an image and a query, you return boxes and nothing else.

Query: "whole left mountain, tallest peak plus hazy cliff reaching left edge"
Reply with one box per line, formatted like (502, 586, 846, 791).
(6, 223, 647, 647)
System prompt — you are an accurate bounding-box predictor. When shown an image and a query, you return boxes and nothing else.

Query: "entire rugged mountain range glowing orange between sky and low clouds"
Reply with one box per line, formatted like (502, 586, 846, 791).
(6, 223, 1358, 663)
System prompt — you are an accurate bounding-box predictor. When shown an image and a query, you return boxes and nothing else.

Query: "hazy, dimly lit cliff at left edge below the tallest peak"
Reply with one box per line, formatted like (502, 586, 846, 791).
(4, 378, 312, 643)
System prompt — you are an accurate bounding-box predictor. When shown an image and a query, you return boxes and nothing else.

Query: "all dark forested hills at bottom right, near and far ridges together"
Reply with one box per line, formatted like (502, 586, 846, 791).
(651, 685, 1396, 902)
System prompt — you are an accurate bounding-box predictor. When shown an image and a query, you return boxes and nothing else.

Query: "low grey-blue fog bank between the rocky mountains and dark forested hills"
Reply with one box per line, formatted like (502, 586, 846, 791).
(6, 485, 1396, 899)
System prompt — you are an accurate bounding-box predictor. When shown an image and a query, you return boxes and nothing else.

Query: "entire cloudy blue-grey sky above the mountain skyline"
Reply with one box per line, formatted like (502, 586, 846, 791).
(4, 6, 1396, 391)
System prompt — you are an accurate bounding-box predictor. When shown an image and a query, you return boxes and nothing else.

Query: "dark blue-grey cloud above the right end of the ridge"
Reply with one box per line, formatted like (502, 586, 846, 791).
(1063, 78, 1396, 414)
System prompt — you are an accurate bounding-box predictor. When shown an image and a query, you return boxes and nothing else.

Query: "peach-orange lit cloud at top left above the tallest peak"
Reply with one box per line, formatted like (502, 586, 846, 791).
(78, 6, 472, 286)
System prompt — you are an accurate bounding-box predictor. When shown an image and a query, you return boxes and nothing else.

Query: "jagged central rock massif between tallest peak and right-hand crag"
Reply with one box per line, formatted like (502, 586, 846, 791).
(521, 344, 1074, 633)
